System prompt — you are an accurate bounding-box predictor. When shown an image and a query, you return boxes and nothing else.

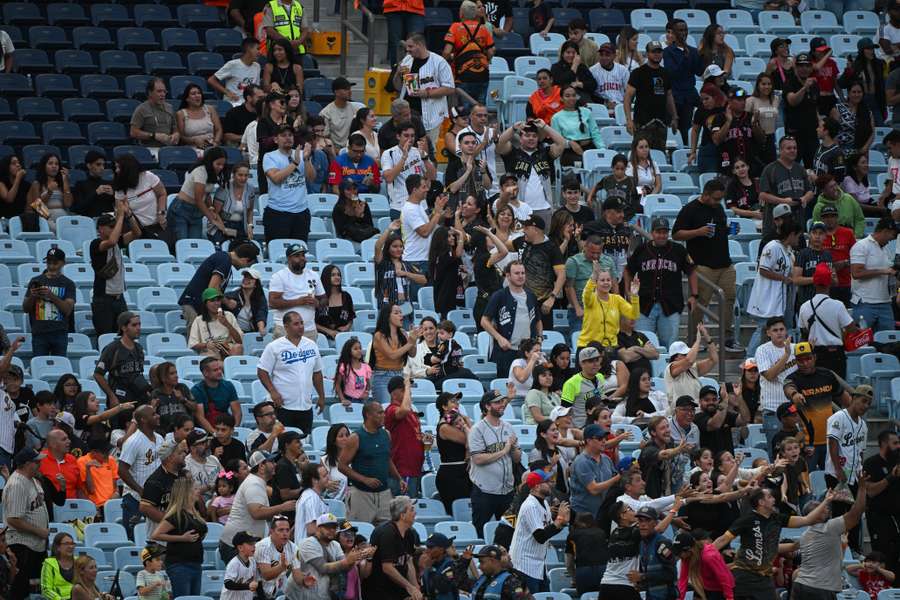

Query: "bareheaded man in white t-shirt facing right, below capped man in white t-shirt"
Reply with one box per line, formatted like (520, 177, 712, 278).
(400, 174, 449, 298)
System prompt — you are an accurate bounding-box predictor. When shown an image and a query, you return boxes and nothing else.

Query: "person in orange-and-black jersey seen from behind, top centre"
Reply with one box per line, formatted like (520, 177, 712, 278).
(443, 0, 494, 104)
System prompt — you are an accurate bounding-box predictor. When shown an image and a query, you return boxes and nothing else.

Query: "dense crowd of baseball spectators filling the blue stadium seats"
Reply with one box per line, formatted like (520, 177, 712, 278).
(0, 0, 900, 600)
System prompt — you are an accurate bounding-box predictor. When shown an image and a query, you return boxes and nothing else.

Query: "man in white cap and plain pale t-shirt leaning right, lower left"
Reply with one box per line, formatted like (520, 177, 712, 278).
(219, 452, 294, 564)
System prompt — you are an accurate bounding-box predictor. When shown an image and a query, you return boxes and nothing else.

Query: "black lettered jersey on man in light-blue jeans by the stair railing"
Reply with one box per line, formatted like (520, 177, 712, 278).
(627, 242, 694, 316)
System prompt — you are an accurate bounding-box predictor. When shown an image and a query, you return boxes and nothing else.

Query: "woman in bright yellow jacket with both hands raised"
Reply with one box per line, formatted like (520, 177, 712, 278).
(578, 262, 640, 349)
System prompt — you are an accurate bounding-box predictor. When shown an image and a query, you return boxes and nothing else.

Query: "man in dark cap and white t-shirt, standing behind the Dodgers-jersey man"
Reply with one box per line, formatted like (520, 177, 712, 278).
(269, 244, 325, 341)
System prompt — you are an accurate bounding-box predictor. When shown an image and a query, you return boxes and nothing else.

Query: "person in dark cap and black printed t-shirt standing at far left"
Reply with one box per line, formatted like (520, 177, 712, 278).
(22, 248, 75, 356)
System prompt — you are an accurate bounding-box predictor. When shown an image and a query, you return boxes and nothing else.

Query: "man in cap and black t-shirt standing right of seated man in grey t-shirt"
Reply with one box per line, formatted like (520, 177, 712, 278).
(623, 41, 676, 151)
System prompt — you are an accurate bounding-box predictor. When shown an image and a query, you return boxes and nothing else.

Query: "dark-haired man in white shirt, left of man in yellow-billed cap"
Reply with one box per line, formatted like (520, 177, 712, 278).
(755, 317, 797, 448)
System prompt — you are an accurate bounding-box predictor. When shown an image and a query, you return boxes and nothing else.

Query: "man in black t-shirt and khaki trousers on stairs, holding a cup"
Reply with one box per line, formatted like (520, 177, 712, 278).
(672, 179, 743, 352)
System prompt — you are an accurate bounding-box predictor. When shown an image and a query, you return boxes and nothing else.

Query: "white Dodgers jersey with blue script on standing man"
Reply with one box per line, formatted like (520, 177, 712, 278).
(259, 336, 322, 414)
